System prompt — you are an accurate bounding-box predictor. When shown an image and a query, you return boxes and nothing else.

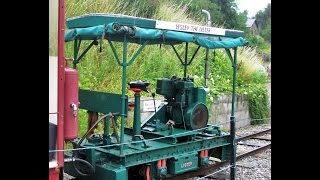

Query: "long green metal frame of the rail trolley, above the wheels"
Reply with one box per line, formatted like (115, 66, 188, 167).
(68, 133, 229, 167)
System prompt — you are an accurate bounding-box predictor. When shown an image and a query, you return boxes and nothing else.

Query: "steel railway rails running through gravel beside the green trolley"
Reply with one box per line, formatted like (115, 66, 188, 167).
(166, 128, 271, 180)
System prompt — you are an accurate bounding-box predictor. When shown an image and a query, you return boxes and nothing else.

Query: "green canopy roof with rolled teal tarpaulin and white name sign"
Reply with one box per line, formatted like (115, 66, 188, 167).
(65, 14, 247, 49)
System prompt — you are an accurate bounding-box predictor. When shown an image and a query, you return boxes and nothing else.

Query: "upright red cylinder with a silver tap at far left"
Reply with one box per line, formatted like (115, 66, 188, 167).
(64, 68, 79, 141)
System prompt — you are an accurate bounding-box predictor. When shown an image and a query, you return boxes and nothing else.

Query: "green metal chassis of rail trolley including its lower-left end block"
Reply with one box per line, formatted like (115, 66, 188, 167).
(65, 125, 231, 180)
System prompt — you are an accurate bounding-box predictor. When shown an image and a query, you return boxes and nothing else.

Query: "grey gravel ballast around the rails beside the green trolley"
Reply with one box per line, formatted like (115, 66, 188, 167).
(64, 124, 271, 180)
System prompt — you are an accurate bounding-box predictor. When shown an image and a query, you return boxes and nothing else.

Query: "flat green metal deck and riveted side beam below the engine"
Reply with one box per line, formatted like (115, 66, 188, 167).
(71, 132, 230, 167)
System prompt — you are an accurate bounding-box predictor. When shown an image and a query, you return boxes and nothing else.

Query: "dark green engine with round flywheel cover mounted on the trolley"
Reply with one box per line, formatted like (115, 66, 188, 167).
(156, 77, 209, 130)
